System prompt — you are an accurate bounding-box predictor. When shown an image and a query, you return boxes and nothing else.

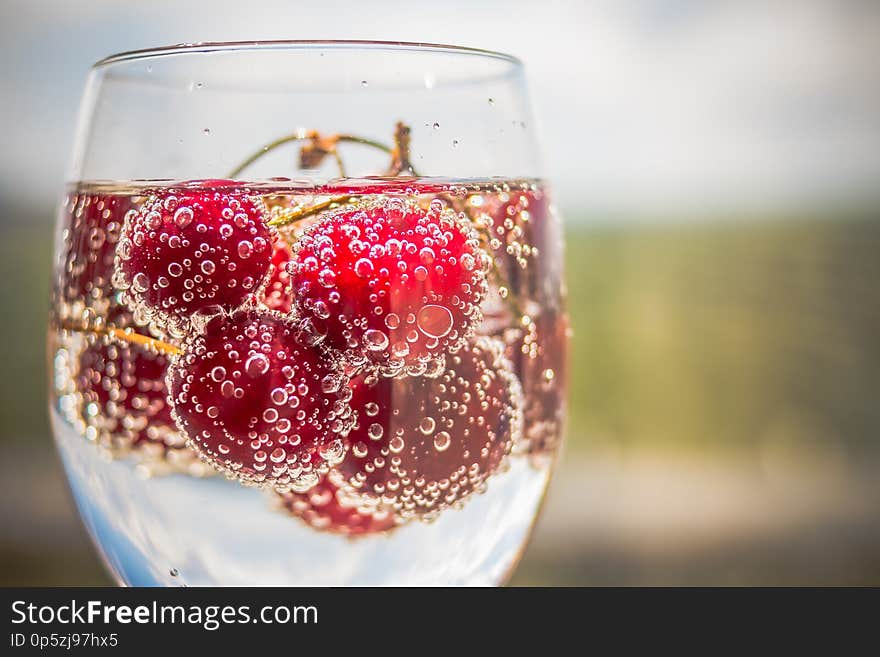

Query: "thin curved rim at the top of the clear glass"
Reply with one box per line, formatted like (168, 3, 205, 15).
(92, 39, 523, 69)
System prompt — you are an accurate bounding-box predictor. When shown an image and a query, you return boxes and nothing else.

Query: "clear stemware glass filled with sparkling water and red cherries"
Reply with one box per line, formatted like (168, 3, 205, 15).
(49, 41, 568, 585)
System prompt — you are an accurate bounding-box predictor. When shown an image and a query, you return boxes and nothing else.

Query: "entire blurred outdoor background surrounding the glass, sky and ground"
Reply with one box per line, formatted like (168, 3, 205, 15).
(0, 0, 880, 585)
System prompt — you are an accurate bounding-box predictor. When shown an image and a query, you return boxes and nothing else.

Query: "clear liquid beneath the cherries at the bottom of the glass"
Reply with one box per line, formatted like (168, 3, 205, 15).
(53, 413, 550, 586)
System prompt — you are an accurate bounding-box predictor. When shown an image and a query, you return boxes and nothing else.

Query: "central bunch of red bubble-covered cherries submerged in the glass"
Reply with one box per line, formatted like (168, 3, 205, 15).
(72, 188, 523, 534)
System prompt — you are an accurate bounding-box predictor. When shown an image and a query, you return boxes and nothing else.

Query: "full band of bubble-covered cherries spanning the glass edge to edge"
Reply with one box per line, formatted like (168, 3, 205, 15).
(54, 181, 568, 536)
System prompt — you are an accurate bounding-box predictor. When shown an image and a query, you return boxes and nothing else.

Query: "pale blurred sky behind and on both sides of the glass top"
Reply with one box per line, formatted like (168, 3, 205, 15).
(0, 0, 880, 217)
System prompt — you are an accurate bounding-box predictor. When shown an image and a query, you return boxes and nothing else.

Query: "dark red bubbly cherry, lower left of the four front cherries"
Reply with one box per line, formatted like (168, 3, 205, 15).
(167, 310, 354, 491)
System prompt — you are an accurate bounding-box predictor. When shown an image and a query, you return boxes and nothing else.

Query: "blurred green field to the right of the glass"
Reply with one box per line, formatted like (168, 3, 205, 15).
(567, 218, 880, 450)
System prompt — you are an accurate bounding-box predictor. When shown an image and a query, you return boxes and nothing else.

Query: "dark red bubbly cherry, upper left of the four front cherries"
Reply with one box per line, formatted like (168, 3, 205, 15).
(114, 190, 272, 333)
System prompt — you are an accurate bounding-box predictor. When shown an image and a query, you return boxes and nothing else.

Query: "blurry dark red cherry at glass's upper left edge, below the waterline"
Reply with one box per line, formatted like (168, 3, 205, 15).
(55, 193, 132, 306)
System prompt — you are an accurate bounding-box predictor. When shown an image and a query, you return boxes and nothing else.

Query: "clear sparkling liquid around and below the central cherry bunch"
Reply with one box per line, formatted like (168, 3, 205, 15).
(50, 181, 567, 586)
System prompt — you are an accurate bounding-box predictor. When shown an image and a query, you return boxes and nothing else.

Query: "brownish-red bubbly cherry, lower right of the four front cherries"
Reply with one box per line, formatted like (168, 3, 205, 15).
(330, 337, 522, 519)
